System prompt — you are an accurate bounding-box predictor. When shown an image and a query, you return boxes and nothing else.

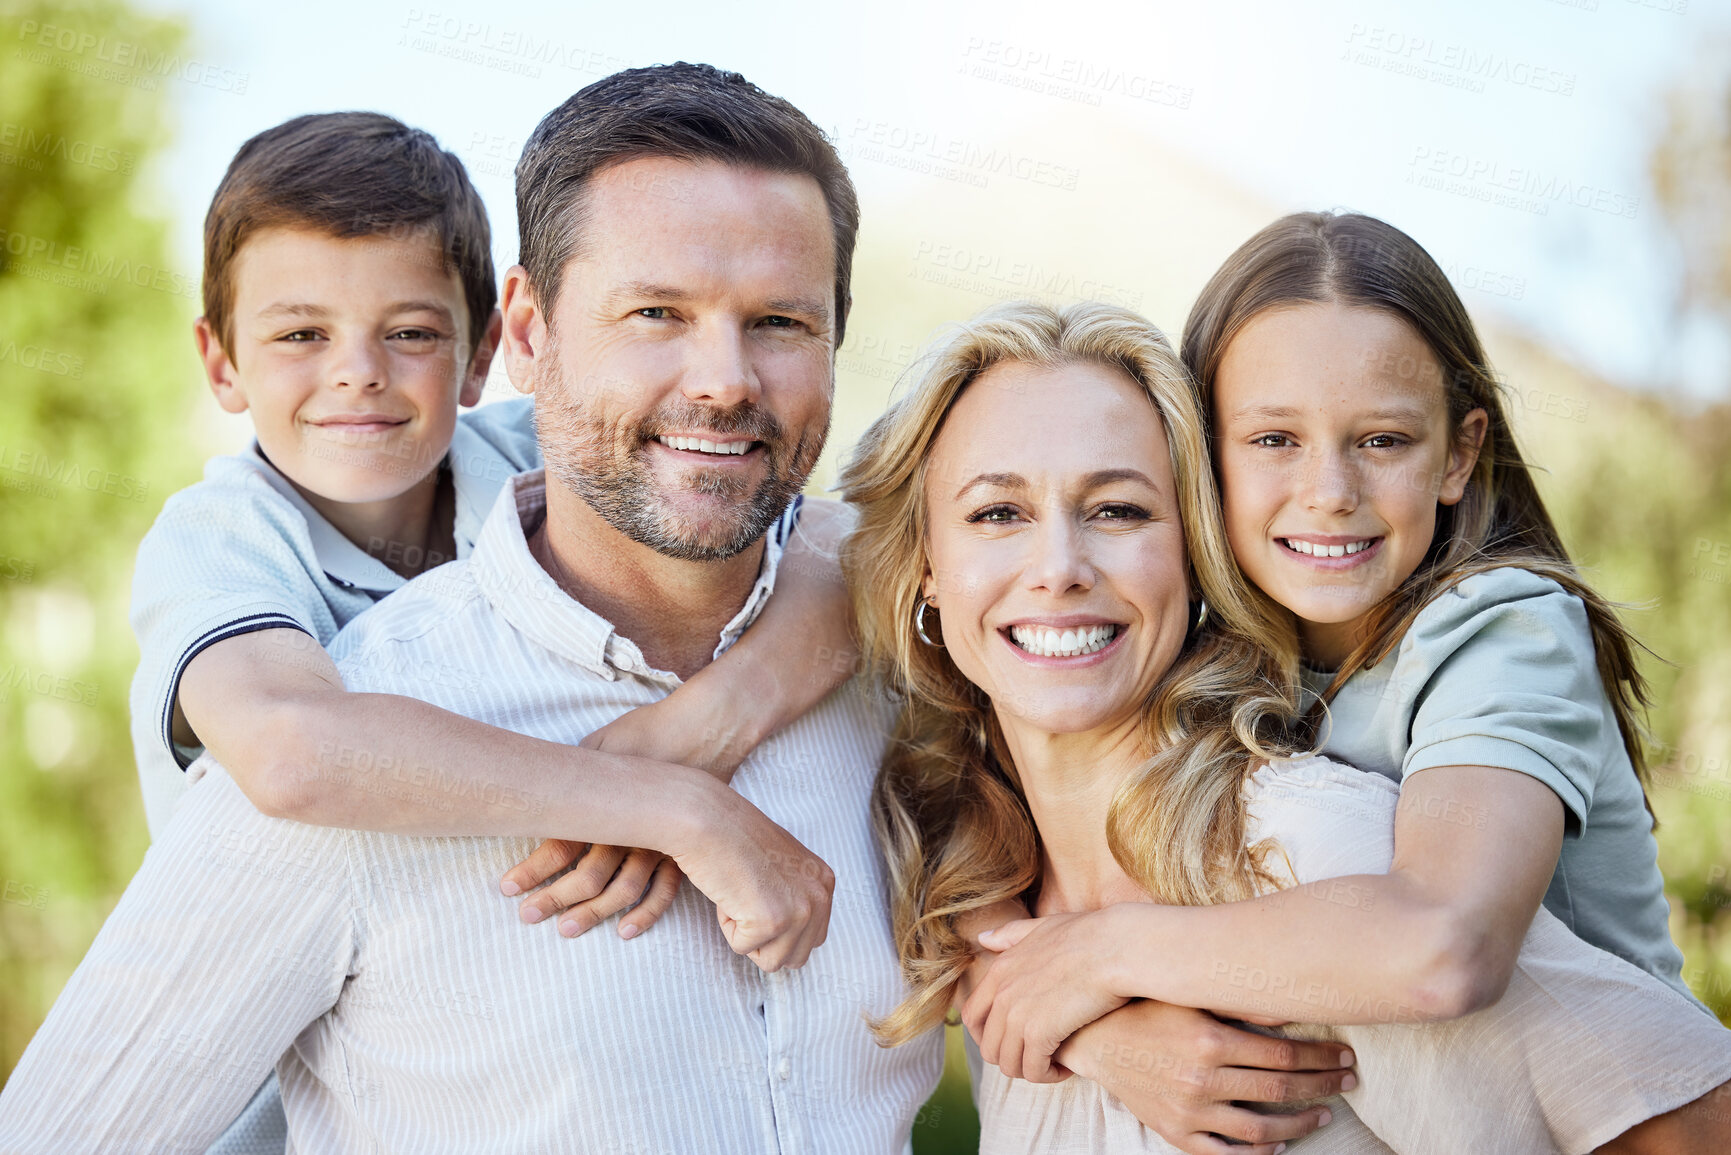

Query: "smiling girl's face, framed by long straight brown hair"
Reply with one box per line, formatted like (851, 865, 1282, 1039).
(1213, 303, 1487, 667)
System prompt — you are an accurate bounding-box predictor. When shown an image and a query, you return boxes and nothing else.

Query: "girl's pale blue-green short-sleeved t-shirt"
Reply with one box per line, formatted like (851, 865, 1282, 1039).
(1305, 568, 1695, 999)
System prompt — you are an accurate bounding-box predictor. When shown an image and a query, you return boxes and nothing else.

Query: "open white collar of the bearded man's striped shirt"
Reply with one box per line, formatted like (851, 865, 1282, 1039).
(469, 469, 800, 686)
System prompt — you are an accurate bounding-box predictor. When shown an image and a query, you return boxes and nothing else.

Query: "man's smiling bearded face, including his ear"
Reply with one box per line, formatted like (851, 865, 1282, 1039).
(505, 158, 836, 561)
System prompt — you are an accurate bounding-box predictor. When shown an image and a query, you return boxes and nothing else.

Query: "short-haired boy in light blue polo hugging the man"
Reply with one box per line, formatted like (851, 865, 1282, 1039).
(132, 113, 852, 1146)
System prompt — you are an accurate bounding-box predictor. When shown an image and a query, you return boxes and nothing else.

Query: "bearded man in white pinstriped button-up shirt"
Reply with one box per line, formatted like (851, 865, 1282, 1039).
(0, 64, 942, 1155)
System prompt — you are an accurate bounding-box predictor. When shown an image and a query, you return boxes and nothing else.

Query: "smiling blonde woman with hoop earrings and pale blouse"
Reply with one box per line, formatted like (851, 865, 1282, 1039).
(841, 305, 1731, 1152)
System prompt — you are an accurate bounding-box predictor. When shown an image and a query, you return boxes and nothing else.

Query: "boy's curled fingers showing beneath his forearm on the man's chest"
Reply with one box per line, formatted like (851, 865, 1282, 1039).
(499, 838, 684, 939)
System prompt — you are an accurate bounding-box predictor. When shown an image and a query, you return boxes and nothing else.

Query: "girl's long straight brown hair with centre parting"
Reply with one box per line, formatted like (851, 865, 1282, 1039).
(1184, 213, 1651, 796)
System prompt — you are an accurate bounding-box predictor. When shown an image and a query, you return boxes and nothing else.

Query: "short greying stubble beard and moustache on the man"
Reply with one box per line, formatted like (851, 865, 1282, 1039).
(535, 341, 827, 561)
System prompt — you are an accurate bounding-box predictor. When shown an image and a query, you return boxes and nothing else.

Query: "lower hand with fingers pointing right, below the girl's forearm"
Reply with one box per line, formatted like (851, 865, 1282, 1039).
(1059, 997, 1357, 1155)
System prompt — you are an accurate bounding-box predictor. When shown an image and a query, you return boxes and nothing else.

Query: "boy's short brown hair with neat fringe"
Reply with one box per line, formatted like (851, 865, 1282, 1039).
(204, 113, 499, 357)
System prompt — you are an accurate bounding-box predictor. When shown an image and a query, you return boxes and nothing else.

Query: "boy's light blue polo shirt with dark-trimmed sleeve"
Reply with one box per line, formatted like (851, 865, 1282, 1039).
(132, 398, 542, 838)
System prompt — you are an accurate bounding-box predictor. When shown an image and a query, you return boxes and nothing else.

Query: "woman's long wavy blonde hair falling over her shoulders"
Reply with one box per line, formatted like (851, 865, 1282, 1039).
(840, 301, 1298, 1044)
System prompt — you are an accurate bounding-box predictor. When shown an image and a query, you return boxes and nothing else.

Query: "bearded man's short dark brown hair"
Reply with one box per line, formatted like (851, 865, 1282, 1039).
(518, 61, 860, 348)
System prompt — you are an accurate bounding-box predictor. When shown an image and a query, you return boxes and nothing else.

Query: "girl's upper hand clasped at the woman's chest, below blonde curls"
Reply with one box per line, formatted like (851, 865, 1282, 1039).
(962, 907, 1132, 1082)
